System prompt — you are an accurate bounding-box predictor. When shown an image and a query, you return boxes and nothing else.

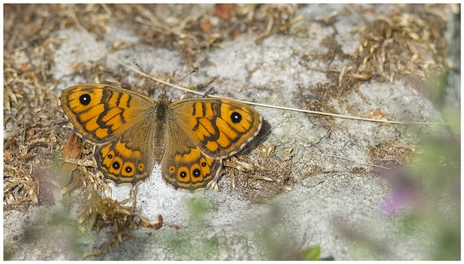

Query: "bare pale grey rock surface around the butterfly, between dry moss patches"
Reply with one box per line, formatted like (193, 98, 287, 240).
(4, 5, 460, 260)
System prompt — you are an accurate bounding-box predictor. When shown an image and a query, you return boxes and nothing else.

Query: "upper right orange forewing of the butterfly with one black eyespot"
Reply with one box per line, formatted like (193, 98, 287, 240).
(172, 98, 262, 158)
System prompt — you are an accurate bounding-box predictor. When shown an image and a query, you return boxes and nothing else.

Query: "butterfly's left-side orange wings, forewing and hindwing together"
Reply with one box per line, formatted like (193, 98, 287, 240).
(60, 84, 159, 183)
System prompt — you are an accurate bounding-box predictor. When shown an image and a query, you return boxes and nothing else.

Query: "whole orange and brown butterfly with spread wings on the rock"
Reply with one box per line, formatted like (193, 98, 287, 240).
(60, 84, 262, 192)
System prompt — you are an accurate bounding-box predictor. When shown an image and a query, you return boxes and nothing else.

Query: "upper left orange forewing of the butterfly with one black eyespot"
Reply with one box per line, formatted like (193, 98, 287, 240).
(60, 84, 155, 143)
